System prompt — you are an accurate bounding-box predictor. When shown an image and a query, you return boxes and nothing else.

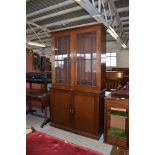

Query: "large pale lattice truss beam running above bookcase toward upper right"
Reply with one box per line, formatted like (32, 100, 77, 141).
(74, 0, 126, 44)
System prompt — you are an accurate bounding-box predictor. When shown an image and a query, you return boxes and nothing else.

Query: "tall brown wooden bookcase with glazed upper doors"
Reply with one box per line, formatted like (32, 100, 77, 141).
(51, 24, 106, 139)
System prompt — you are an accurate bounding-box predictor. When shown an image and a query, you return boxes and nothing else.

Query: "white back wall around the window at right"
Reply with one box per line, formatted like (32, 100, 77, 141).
(106, 41, 129, 69)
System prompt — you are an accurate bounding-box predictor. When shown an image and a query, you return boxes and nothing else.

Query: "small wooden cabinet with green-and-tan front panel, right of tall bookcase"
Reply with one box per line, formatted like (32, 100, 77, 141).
(104, 91, 129, 149)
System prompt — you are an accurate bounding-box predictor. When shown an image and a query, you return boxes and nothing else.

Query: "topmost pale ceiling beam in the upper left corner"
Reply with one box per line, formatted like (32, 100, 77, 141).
(26, 0, 74, 18)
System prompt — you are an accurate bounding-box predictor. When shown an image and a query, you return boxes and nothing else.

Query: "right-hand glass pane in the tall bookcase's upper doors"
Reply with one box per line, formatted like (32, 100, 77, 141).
(76, 32, 96, 86)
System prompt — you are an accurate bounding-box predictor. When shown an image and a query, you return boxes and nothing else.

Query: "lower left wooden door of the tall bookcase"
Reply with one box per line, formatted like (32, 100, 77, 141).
(51, 90, 71, 126)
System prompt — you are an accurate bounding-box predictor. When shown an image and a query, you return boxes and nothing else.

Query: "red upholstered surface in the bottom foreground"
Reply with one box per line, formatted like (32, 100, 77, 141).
(26, 131, 103, 155)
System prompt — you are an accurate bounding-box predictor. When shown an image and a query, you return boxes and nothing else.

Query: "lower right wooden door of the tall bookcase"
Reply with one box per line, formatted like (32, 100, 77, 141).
(73, 93, 98, 134)
